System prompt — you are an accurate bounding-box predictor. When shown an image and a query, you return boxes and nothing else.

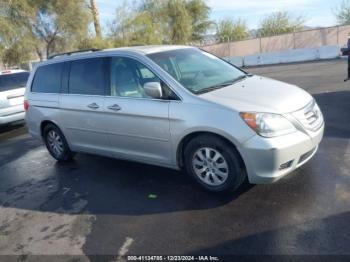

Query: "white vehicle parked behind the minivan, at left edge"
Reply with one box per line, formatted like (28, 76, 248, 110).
(0, 70, 29, 125)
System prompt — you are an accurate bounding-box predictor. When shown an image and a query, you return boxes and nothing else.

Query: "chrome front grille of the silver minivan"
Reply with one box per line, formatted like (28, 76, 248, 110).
(293, 100, 323, 131)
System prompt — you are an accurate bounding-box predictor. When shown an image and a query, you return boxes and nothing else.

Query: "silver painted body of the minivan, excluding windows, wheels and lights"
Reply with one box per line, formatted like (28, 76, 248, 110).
(26, 46, 324, 183)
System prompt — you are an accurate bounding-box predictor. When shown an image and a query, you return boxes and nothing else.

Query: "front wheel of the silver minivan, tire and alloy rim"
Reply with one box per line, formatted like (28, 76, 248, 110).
(184, 135, 247, 192)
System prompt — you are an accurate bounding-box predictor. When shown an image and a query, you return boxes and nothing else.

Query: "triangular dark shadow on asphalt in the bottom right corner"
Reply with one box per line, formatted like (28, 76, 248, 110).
(191, 212, 350, 256)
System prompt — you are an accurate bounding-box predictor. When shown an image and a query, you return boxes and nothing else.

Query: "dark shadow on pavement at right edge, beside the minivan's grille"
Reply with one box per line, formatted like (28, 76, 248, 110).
(314, 91, 350, 138)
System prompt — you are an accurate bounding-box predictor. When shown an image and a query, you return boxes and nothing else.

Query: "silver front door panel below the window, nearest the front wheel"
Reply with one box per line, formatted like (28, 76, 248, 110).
(104, 97, 172, 165)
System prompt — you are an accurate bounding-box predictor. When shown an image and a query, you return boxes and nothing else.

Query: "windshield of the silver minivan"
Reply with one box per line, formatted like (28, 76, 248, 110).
(148, 48, 249, 94)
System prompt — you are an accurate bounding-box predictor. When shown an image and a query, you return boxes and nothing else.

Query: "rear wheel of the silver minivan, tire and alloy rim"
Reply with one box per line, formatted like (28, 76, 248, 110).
(43, 124, 75, 162)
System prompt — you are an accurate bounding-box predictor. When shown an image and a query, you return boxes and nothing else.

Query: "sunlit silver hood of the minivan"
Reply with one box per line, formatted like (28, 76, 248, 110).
(200, 76, 312, 114)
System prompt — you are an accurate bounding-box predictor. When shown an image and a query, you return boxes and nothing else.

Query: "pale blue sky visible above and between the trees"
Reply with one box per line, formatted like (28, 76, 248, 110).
(97, 0, 342, 29)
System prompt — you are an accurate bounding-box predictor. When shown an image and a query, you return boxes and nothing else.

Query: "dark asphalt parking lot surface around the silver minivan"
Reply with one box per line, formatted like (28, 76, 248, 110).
(0, 60, 350, 258)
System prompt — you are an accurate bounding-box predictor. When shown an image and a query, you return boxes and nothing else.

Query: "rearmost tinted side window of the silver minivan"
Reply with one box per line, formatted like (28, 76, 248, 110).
(32, 63, 63, 93)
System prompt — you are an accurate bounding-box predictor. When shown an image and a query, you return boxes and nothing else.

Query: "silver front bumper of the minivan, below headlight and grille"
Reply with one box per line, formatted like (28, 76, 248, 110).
(239, 124, 324, 184)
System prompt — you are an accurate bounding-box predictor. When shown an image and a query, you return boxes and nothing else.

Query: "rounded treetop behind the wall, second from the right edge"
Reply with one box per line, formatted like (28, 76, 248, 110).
(258, 11, 305, 36)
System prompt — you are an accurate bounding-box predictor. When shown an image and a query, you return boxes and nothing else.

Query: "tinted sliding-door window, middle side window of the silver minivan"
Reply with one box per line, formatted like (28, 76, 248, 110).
(69, 58, 108, 95)
